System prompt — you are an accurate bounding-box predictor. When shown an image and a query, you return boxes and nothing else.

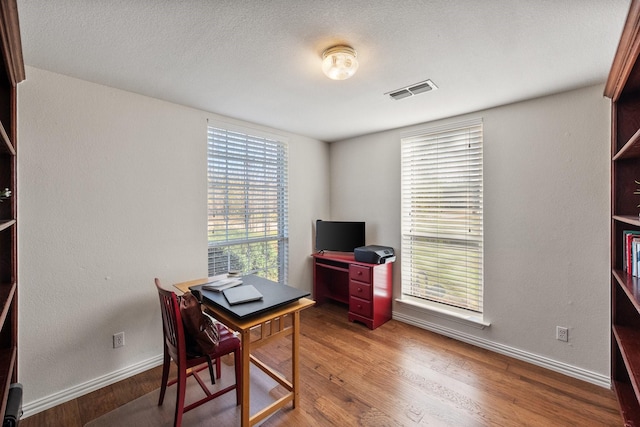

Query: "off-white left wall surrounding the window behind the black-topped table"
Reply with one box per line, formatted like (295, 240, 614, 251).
(18, 67, 329, 415)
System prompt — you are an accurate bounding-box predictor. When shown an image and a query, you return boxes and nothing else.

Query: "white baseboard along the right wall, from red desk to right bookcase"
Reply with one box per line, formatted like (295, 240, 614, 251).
(393, 311, 611, 389)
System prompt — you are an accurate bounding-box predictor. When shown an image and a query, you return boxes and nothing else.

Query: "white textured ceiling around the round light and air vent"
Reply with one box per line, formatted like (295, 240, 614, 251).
(18, 0, 630, 141)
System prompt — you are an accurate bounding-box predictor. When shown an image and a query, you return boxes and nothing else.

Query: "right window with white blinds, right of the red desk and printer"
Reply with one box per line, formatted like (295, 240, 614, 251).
(401, 120, 483, 313)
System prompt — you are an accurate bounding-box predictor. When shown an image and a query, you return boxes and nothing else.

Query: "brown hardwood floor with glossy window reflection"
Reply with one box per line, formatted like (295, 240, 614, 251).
(20, 303, 623, 427)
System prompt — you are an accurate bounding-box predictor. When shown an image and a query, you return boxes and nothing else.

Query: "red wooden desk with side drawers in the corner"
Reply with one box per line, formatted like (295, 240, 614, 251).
(313, 252, 393, 329)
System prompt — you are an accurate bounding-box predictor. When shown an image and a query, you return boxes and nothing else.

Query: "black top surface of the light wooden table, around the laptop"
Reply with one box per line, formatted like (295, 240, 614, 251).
(189, 275, 311, 318)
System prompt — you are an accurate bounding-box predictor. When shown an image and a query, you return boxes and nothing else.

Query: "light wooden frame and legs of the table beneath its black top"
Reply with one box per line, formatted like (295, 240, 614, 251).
(174, 278, 315, 427)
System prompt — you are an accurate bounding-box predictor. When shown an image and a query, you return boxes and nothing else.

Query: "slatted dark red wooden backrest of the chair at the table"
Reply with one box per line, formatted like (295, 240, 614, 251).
(155, 278, 187, 366)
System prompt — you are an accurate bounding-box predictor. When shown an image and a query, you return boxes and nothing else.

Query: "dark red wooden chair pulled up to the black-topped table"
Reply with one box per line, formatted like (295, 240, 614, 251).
(155, 279, 242, 427)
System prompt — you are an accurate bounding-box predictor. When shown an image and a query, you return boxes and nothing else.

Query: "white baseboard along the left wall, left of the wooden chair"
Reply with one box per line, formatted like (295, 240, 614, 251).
(22, 354, 163, 418)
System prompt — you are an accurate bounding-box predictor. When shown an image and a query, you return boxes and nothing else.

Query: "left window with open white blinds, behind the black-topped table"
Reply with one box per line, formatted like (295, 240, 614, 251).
(208, 127, 288, 283)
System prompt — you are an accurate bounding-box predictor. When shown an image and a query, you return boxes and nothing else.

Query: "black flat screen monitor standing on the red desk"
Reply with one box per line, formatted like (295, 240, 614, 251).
(316, 219, 365, 252)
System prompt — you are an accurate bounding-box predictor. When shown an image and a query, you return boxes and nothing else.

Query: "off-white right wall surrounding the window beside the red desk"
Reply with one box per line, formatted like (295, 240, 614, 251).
(330, 86, 610, 385)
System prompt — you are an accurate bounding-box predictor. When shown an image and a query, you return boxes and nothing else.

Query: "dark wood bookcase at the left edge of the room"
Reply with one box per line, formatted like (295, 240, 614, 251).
(0, 0, 25, 418)
